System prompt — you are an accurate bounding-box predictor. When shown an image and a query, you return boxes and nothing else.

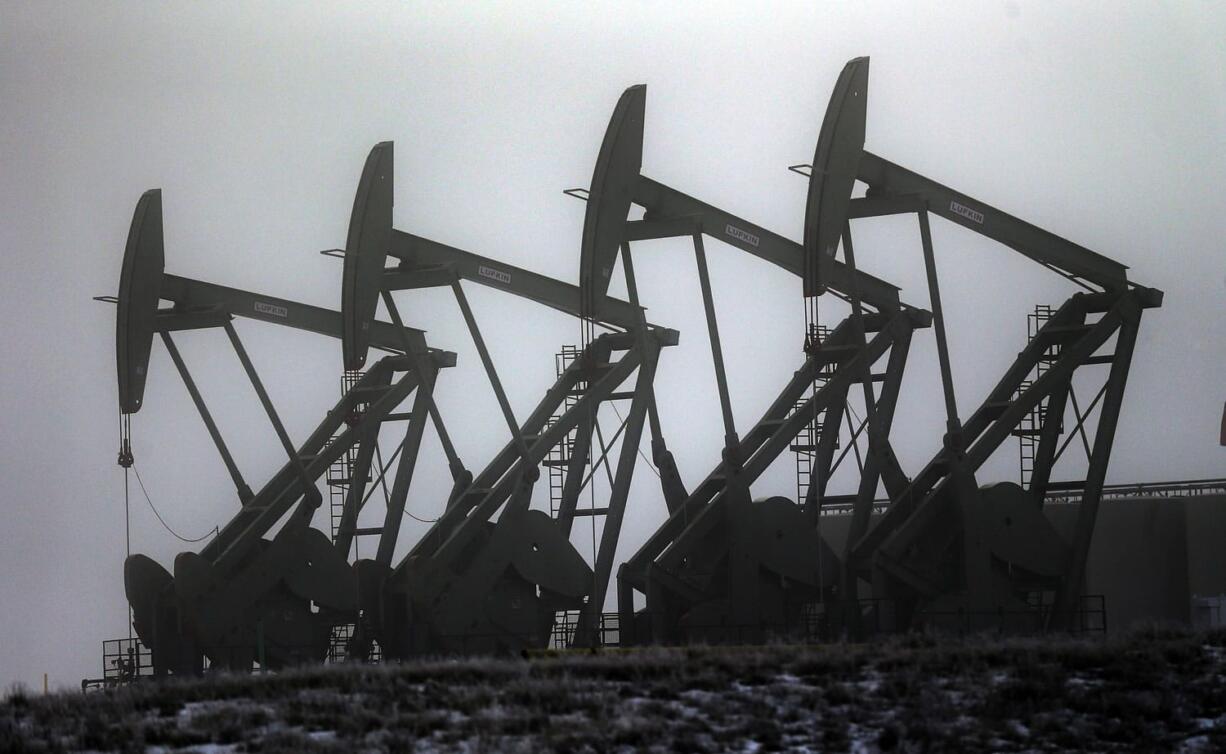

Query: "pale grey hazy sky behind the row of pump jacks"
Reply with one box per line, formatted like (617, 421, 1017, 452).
(0, 0, 1226, 687)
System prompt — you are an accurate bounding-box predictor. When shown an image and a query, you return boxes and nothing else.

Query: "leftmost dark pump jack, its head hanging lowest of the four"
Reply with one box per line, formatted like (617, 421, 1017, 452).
(103, 190, 455, 674)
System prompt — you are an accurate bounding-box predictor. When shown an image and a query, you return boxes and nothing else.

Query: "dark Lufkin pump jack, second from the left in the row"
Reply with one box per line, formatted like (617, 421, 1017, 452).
(331, 142, 680, 657)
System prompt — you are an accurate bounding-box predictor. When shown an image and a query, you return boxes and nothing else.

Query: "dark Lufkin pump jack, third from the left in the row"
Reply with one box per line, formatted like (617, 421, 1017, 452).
(580, 86, 931, 644)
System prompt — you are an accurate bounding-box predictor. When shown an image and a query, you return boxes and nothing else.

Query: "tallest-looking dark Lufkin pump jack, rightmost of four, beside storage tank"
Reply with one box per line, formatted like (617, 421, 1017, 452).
(805, 58, 1162, 630)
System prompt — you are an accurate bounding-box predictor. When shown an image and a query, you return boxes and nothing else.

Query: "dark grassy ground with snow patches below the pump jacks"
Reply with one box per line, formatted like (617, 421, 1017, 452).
(0, 629, 1226, 752)
